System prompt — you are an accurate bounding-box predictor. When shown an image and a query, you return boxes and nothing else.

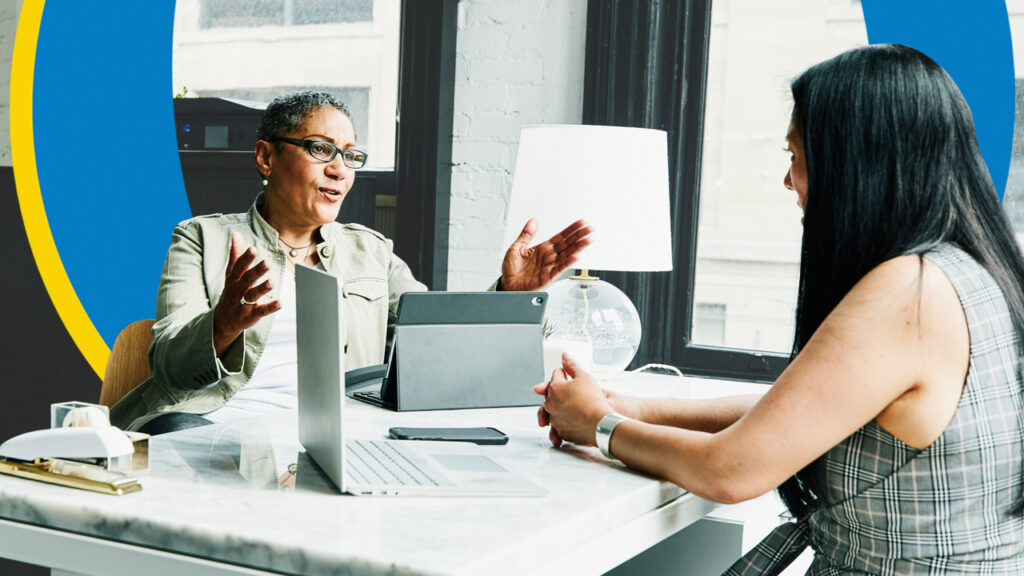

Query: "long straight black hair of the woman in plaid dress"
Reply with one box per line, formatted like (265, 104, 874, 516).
(780, 44, 1024, 518)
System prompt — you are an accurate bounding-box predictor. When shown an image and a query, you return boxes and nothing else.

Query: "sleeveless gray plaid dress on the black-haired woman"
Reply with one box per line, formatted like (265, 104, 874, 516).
(725, 244, 1024, 576)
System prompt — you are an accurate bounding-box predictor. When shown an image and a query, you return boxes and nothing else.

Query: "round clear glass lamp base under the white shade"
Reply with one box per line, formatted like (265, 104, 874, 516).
(545, 277, 642, 376)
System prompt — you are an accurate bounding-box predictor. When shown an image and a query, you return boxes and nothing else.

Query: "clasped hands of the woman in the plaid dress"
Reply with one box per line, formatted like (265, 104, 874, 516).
(534, 354, 613, 447)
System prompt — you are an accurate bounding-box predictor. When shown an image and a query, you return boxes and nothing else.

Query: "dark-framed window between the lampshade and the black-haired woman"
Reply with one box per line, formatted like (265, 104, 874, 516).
(584, 0, 866, 380)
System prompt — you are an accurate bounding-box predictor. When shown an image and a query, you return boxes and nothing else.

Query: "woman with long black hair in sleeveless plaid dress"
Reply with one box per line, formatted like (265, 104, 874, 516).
(537, 45, 1024, 574)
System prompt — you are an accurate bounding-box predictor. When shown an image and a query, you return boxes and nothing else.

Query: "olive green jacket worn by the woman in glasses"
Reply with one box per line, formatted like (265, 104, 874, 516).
(111, 194, 427, 429)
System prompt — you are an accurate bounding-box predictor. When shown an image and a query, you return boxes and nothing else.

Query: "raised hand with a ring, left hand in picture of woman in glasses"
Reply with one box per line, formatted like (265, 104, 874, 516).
(213, 232, 281, 356)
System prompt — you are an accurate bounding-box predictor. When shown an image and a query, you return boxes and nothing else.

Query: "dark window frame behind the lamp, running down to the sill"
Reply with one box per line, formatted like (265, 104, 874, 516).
(583, 0, 790, 382)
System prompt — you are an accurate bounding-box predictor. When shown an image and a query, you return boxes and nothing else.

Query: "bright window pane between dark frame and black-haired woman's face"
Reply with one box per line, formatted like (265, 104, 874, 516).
(691, 0, 867, 353)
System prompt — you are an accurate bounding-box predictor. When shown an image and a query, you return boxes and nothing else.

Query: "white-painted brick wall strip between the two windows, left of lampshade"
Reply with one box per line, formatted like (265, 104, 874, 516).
(447, 0, 587, 290)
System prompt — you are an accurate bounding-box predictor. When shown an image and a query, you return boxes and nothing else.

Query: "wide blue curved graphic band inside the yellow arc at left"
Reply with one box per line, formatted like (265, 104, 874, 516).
(33, 0, 190, 345)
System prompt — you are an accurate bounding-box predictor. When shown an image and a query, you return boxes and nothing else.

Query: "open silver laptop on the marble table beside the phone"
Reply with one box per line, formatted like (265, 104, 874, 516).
(295, 264, 547, 496)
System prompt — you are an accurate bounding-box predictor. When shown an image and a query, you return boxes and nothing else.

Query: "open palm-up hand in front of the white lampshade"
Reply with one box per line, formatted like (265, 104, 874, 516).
(498, 218, 593, 291)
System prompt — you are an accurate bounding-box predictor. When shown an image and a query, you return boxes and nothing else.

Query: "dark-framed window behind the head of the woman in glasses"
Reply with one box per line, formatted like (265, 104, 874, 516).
(168, 0, 458, 289)
